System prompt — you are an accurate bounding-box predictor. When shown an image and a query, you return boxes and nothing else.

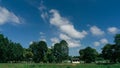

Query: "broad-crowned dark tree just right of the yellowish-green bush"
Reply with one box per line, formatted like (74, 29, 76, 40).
(30, 41, 47, 63)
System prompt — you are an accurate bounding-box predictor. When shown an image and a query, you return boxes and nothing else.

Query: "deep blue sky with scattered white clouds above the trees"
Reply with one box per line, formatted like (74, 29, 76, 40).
(0, 0, 120, 56)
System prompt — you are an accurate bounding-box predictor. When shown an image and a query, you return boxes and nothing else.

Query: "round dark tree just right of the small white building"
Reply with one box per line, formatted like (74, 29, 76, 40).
(79, 47, 98, 63)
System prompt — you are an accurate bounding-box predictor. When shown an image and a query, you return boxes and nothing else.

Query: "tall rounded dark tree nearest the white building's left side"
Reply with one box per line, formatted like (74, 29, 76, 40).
(53, 40, 69, 63)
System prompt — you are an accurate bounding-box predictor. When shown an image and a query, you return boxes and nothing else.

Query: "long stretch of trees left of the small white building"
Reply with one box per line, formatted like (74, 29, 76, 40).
(0, 34, 69, 63)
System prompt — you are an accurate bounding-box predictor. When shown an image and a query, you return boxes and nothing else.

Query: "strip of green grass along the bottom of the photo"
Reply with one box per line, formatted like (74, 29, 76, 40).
(0, 63, 120, 68)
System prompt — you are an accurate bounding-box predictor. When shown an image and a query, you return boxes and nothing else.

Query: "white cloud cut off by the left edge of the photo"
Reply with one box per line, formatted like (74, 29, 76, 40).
(0, 7, 20, 25)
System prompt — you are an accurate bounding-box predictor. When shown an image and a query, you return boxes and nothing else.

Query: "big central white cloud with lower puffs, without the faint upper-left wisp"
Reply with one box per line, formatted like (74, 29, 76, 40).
(50, 9, 87, 47)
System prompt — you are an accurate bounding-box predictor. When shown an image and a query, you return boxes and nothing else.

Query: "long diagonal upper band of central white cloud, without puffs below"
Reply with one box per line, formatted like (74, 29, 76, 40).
(50, 9, 87, 39)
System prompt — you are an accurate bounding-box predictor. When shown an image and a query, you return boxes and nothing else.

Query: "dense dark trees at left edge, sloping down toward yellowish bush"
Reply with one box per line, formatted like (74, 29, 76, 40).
(0, 34, 23, 62)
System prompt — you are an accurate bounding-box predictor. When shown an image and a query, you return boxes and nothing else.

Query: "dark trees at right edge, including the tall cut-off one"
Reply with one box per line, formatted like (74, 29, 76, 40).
(102, 34, 120, 63)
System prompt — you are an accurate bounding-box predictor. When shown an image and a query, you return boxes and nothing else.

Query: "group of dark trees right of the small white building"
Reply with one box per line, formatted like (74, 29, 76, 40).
(79, 34, 120, 63)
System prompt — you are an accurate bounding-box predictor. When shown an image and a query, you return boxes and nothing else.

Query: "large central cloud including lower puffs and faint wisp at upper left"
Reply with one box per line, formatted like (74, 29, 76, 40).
(39, 2, 87, 47)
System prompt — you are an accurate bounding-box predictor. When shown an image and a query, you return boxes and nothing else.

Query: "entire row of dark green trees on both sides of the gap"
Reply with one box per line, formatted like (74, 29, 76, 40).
(0, 34, 120, 63)
